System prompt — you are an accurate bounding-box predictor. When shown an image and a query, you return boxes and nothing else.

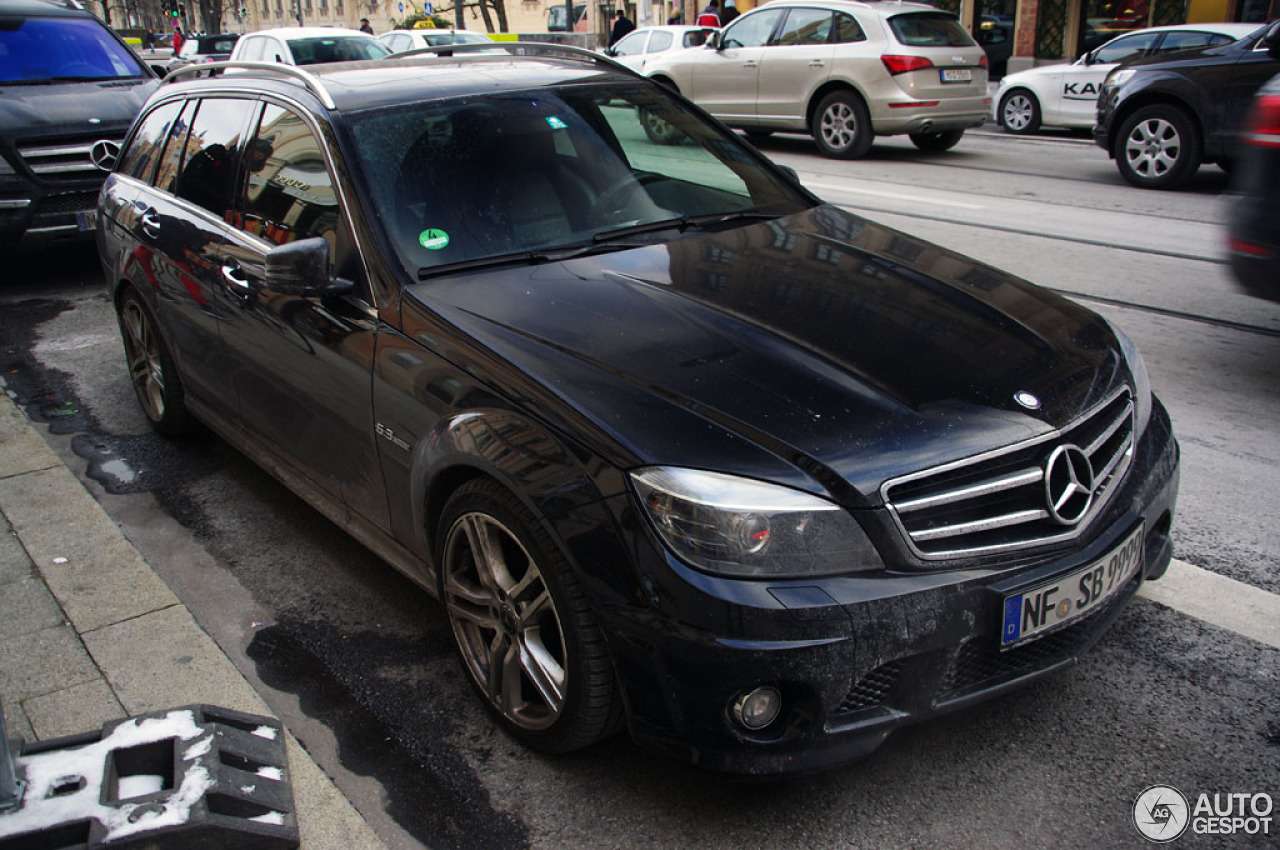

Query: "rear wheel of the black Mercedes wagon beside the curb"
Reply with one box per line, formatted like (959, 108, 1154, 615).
(116, 289, 191, 437)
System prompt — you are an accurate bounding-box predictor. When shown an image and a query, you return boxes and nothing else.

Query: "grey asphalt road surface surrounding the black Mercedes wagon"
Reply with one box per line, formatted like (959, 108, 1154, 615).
(0, 133, 1280, 847)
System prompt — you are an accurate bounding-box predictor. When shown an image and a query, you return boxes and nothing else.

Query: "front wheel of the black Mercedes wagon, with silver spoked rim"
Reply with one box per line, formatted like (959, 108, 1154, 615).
(436, 479, 622, 753)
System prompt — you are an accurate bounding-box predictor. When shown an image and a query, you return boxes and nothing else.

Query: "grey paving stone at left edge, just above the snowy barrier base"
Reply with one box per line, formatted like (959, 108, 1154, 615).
(0, 626, 99, 704)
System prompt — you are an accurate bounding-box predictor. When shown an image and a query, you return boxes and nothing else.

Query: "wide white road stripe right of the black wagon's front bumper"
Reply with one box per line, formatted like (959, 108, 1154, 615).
(1138, 558, 1280, 649)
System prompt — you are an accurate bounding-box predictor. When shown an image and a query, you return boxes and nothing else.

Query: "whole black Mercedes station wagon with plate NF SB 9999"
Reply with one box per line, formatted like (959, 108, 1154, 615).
(97, 44, 1178, 776)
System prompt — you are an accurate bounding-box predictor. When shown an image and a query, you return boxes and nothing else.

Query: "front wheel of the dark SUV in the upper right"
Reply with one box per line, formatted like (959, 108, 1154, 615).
(1114, 104, 1201, 189)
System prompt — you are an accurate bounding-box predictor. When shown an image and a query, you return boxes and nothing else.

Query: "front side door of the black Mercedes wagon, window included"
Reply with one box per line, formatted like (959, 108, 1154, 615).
(215, 102, 387, 527)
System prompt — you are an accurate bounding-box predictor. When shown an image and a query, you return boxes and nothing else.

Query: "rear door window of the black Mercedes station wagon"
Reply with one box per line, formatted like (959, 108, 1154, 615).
(178, 97, 257, 221)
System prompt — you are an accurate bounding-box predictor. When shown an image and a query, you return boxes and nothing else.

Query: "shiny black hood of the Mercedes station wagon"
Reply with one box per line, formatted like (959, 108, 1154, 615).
(410, 206, 1124, 504)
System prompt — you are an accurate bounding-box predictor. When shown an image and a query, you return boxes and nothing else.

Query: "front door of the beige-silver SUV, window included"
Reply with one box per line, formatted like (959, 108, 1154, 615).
(691, 9, 785, 123)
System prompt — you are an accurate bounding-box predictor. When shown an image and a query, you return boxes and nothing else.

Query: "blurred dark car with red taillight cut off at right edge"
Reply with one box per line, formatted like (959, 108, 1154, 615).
(1226, 76, 1280, 301)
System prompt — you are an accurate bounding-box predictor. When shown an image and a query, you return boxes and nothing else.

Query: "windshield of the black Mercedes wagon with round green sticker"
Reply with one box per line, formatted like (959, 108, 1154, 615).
(352, 83, 812, 273)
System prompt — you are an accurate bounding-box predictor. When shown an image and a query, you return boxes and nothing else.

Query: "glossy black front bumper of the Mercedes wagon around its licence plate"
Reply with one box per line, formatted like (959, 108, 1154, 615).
(603, 402, 1178, 776)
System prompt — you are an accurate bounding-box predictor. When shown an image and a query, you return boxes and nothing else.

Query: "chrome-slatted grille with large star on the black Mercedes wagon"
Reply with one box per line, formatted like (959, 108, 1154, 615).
(881, 388, 1134, 561)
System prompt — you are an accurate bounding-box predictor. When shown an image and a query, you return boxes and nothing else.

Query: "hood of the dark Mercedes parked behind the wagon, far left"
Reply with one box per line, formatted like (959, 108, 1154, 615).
(0, 77, 160, 142)
